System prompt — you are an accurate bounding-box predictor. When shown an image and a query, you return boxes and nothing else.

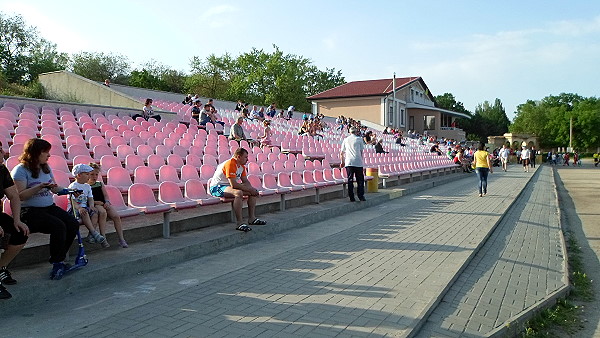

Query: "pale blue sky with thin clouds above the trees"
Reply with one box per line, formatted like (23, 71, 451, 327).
(0, 0, 600, 119)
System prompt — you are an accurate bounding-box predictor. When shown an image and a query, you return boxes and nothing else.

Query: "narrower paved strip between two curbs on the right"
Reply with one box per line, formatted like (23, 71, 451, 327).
(419, 167, 567, 337)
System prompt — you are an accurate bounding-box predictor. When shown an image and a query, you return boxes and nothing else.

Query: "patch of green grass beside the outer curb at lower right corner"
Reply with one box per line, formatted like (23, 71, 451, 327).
(521, 233, 595, 337)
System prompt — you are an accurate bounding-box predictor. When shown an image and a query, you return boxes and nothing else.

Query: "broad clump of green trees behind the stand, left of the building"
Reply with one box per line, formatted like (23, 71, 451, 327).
(186, 46, 345, 111)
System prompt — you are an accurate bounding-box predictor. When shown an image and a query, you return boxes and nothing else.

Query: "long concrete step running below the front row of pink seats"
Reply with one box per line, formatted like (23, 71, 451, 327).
(0, 175, 467, 314)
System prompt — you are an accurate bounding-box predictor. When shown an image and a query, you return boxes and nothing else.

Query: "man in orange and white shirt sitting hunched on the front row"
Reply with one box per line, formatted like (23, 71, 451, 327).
(209, 148, 267, 232)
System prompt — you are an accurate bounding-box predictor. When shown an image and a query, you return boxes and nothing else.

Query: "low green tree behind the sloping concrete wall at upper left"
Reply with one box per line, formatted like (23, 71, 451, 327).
(69, 52, 130, 84)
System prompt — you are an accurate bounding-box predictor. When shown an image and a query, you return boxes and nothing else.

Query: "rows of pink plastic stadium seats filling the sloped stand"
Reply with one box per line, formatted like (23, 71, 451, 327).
(0, 99, 456, 265)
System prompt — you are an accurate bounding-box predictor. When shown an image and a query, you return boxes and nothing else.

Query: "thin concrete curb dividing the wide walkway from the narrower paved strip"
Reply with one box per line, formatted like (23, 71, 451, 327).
(406, 168, 539, 337)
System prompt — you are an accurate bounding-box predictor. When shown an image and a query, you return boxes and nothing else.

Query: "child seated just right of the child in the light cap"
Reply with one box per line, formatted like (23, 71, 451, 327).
(88, 163, 129, 248)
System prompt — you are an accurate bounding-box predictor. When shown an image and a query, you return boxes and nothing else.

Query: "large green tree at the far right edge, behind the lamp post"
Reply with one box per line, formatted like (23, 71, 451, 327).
(510, 93, 600, 150)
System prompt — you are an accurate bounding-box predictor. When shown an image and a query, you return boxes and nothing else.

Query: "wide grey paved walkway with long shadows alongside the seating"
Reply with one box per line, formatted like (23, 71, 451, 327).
(2, 165, 557, 337)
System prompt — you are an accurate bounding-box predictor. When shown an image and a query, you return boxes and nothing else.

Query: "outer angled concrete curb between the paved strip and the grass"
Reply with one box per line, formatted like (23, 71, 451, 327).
(487, 167, 572, 337)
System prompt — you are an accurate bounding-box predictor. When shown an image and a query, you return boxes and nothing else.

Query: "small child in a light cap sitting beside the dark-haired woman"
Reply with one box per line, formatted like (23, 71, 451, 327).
(67, 164, 110, 248)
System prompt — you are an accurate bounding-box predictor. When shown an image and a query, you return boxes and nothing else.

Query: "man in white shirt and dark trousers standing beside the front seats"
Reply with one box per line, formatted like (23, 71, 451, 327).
(340, 127, 366, 202)
